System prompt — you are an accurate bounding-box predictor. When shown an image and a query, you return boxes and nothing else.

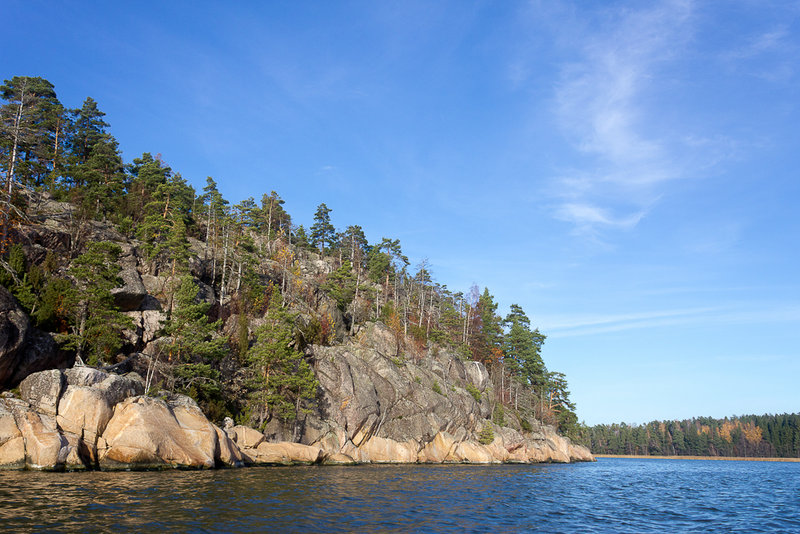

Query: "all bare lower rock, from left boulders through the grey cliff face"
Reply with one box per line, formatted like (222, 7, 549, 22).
(0, 348, 593, 470)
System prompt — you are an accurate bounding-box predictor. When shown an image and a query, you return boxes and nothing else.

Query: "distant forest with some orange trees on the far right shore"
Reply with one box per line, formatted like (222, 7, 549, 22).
(577, 414, 800, 458)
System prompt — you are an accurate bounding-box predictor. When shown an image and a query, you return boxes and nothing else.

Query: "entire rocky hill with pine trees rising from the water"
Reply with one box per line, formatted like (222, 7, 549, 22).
(0, 77, 593, 470)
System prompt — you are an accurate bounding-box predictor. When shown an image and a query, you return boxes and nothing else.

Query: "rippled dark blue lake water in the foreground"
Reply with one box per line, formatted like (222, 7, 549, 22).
(0, 459, 800, 532)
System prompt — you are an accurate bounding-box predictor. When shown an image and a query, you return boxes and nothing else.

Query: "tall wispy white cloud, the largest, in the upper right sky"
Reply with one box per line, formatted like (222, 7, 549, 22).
(553, 1, 692, 233)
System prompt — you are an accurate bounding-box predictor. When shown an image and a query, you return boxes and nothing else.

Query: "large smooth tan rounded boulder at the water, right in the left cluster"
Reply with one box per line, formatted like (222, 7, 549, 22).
(98, 397, 218, 469)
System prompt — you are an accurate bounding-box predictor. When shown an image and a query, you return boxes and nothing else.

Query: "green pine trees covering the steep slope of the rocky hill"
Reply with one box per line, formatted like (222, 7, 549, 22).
(0, 76, 577, 432)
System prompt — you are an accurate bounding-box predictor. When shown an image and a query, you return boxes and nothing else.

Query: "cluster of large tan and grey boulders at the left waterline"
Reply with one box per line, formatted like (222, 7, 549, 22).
(0, 367, 244, 470)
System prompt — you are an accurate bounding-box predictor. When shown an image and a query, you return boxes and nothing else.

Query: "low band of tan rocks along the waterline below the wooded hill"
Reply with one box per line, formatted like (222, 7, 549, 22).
(0, 367, 593, 471)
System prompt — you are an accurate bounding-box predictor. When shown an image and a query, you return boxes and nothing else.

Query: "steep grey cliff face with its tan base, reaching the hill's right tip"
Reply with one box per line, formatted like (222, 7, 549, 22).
(294, 323, 593, 463)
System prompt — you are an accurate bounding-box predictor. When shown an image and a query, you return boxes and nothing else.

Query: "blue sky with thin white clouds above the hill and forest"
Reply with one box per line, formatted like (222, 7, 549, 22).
(0, 0, 800, 425)
